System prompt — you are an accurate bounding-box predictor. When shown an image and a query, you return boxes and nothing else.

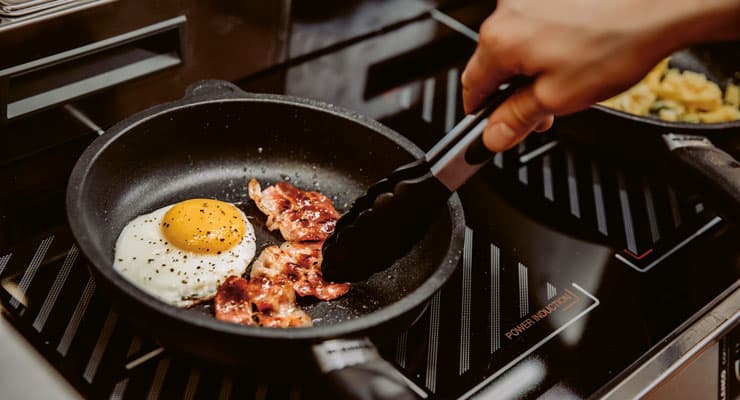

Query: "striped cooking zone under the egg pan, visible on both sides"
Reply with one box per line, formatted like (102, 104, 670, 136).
(0, 219, 596, 399)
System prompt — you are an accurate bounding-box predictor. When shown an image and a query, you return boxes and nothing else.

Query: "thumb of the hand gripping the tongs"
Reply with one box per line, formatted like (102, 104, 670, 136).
(483, 86, 551, 152)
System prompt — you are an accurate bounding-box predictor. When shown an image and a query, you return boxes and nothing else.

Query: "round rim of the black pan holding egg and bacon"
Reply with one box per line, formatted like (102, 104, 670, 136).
(66, 93, 465, 341)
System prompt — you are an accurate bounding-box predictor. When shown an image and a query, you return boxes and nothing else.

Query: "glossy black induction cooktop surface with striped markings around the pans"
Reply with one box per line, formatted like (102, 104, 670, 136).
(0, 7, 740, 399)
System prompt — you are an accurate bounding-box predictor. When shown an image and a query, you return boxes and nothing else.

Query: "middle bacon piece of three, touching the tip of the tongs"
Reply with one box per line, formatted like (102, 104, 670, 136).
(250, 242, 350, 300)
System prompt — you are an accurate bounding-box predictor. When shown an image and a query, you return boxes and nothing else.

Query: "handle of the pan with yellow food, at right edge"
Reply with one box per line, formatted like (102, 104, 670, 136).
(663, 133, 740, 224)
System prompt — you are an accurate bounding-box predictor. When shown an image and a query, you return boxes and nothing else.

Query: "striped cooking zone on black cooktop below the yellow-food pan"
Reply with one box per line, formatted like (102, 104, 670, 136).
(491, 133, 721, 272)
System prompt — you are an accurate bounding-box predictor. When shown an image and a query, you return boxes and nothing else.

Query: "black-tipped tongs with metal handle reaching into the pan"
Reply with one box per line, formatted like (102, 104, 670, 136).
(322, 78, 528, 282)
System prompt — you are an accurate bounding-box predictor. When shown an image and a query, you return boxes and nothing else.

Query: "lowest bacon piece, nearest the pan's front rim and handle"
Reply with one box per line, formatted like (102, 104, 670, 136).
(214, 276, 311, 328)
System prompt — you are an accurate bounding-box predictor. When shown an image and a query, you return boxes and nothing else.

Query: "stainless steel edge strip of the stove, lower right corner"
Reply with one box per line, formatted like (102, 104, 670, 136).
(601, 287, 740, 400)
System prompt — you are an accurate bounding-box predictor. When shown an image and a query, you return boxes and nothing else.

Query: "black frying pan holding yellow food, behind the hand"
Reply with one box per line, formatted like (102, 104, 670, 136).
(558, 46, 740, 223)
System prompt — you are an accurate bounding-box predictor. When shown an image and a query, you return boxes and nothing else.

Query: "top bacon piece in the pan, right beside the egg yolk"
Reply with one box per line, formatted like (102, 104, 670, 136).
(249, 179, 339, 242)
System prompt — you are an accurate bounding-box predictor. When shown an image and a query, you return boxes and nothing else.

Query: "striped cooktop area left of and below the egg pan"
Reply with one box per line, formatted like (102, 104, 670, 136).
(0, 242, 330, 399)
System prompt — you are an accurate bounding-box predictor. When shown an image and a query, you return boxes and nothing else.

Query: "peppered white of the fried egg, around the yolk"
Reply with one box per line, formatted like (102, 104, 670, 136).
(113, 204, 256, 307)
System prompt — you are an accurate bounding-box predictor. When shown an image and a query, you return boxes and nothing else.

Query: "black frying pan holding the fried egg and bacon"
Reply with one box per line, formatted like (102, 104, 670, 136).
(66, 81, 464, 398)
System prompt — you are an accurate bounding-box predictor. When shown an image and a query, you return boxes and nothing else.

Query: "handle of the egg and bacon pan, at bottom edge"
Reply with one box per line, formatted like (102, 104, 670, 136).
(312, 338, 428, 400)
